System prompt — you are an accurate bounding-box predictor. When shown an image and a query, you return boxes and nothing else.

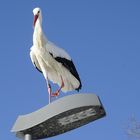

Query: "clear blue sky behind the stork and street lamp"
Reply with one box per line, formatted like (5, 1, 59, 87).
(0, 0, 140, 140)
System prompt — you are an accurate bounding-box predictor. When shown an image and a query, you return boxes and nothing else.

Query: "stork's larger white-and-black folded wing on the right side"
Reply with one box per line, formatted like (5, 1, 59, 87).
(46, 42, 82, 90)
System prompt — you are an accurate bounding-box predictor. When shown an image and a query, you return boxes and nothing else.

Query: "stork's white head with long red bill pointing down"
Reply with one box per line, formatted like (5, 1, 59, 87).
(33, 7, 42, 27)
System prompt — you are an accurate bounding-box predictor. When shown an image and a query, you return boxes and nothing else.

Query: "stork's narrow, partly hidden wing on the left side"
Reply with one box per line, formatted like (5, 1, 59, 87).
(30, 48, 42, 73)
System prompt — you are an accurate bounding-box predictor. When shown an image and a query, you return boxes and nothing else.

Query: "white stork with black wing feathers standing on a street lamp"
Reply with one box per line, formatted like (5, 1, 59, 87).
(30, 8, 82, 103)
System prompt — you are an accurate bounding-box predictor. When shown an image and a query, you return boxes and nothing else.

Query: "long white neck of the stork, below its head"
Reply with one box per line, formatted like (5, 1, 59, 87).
(33, 17, 47, 47)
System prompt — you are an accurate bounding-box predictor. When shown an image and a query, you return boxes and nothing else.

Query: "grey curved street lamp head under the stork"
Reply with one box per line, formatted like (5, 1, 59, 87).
(11, 93, 106, 140)
